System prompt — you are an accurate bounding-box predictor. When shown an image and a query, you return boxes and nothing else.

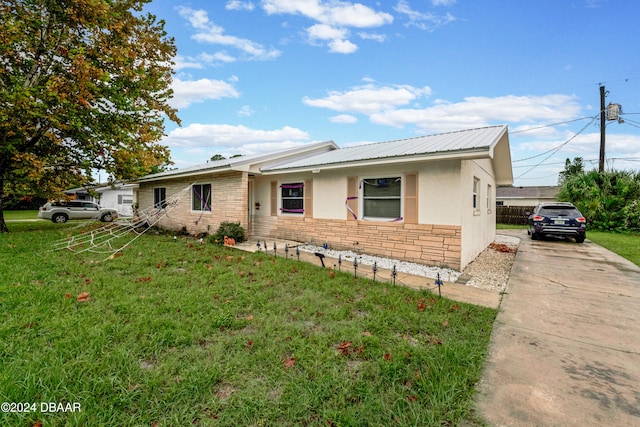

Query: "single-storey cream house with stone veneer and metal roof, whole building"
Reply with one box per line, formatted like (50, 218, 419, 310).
(137, 126, 513, 270)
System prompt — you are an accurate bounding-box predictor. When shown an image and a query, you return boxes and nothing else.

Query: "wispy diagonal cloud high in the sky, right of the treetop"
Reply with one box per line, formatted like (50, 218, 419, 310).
(178, 6, 282, 62)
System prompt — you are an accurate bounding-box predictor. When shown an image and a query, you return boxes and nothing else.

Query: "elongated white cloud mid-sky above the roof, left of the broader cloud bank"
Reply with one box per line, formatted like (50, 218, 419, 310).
(303, 84, 431, 115)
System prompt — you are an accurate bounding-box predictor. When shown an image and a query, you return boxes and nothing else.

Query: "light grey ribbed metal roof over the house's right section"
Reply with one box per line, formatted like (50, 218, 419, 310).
(261, 125, 507, 172)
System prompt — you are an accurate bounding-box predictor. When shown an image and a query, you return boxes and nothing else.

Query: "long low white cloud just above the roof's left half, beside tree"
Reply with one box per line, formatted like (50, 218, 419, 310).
(162, 123, 309, 149)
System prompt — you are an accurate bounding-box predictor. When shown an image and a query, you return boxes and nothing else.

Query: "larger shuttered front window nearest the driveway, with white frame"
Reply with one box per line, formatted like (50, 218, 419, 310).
(362, 177, 402, 219)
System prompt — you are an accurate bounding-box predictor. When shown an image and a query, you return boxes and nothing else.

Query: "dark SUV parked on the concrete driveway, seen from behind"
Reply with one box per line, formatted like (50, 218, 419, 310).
(527, 202, 587, 243)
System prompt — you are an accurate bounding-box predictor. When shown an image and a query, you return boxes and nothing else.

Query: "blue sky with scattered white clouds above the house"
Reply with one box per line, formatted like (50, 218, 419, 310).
(142, 0, 640, 185)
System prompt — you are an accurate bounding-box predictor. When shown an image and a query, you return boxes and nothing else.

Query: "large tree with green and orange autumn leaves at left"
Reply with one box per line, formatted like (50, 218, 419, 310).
(0, 0, 180, 232)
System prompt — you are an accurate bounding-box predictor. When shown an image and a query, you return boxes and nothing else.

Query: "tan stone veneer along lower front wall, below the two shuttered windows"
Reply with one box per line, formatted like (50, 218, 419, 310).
(253, 216, 462, 270)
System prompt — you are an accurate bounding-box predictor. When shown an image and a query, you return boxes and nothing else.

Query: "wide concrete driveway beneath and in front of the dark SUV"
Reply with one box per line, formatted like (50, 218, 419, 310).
(477, 230, 640, 427)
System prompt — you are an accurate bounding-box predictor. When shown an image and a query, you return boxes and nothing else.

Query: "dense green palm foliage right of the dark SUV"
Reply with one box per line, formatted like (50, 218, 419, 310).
(559, 170, 640, 231)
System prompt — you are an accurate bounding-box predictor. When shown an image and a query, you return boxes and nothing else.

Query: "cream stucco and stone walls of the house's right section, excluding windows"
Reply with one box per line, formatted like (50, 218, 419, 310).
(254, 160, 495, 269)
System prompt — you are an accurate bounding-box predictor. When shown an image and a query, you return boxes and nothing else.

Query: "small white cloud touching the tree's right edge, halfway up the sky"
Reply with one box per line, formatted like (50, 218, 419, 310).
(171, 78, 240, 108)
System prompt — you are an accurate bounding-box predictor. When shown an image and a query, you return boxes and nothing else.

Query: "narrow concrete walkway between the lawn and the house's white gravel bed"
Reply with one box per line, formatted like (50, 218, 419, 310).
(235, 237, 501, 308)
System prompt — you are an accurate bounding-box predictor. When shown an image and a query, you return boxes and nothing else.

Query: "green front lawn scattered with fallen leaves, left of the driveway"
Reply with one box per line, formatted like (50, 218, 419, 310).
(0, 222, 496, 426)
